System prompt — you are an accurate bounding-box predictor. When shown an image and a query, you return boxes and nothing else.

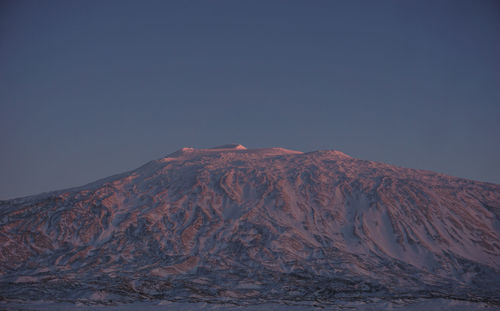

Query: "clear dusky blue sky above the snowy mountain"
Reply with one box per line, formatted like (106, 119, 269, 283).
(0, 0, 500, 199)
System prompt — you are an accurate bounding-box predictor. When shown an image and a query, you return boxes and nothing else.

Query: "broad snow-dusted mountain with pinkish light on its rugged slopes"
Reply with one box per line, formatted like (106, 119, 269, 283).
(0, 144, 500, 305)
